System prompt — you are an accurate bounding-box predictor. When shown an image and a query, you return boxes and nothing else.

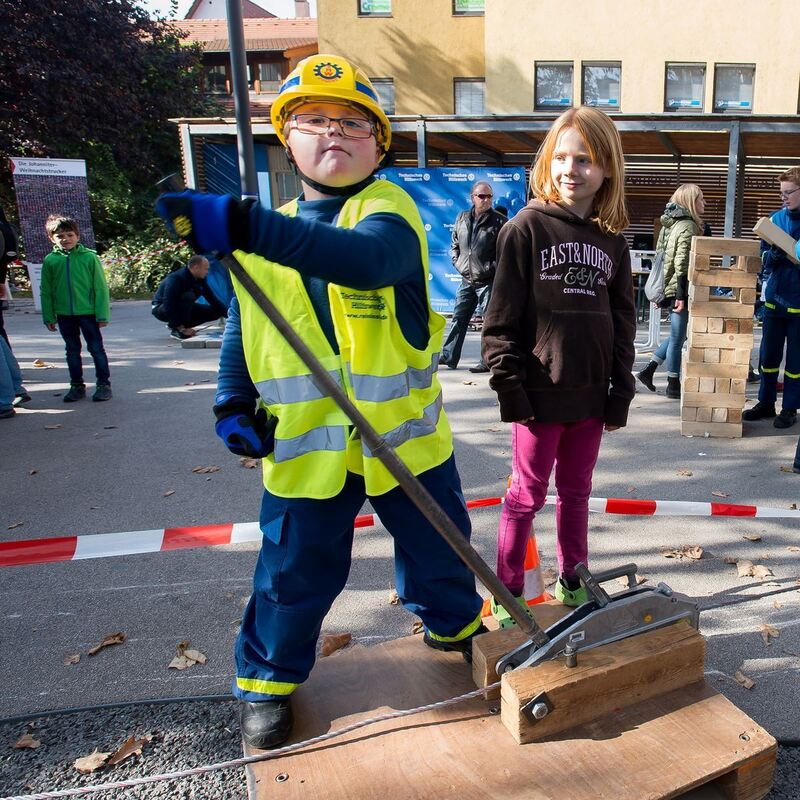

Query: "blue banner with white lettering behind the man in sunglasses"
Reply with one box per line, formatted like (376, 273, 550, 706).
(378, 166, 525, 312)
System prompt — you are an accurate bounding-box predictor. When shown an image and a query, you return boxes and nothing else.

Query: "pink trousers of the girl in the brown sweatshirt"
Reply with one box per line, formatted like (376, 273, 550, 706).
(497, 418, 603, 595)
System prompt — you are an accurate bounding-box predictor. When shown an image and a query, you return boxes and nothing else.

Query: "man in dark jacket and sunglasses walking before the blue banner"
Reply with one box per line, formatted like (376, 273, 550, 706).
(439, 181, 506, 372)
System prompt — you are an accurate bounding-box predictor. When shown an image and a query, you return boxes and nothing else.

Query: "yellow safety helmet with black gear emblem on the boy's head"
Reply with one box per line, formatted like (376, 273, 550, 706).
(270, 53, 392, 153)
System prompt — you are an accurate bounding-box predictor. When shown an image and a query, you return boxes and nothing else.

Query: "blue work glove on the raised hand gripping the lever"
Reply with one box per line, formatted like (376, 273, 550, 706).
(156, 189, 241, 253)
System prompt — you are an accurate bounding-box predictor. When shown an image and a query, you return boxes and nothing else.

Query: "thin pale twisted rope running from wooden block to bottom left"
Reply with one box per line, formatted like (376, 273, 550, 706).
(0, 681, 500, 800)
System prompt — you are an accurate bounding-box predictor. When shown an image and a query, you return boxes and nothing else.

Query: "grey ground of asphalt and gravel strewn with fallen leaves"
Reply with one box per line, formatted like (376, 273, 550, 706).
(0, 299, 800, 799)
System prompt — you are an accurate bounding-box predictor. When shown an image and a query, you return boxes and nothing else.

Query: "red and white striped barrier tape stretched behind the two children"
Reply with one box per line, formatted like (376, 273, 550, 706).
(0, 495, 800, 567)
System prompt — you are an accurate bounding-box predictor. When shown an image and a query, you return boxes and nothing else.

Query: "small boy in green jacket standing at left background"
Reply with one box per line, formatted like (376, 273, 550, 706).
(41, 214, 111, 403)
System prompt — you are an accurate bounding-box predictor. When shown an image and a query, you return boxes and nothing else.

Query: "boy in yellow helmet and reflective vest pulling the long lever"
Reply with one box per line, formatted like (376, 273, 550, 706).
(158, 55, 484, 748)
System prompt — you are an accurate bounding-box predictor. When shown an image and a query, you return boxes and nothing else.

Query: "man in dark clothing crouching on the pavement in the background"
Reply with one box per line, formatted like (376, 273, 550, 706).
(152, 256, 228, 340)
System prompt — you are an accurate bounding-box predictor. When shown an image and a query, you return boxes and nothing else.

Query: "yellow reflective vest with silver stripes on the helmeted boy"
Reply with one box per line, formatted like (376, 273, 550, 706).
(233, 180, 453, 499)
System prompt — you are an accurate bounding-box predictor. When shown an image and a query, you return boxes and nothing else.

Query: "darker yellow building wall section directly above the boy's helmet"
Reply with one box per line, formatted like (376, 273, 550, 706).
(317, 0, 482, 114)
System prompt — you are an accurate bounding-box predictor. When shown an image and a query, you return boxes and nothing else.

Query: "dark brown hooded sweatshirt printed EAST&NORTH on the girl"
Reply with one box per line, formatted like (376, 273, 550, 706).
(482, 200, 636, 426)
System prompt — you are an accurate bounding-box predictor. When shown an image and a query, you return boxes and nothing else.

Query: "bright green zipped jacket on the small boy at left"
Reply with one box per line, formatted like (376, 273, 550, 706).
(41, 243, 111, 325)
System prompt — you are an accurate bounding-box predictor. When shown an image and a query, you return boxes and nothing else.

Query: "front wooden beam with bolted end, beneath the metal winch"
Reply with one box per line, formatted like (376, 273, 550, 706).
(500, 621, 705, 744)
